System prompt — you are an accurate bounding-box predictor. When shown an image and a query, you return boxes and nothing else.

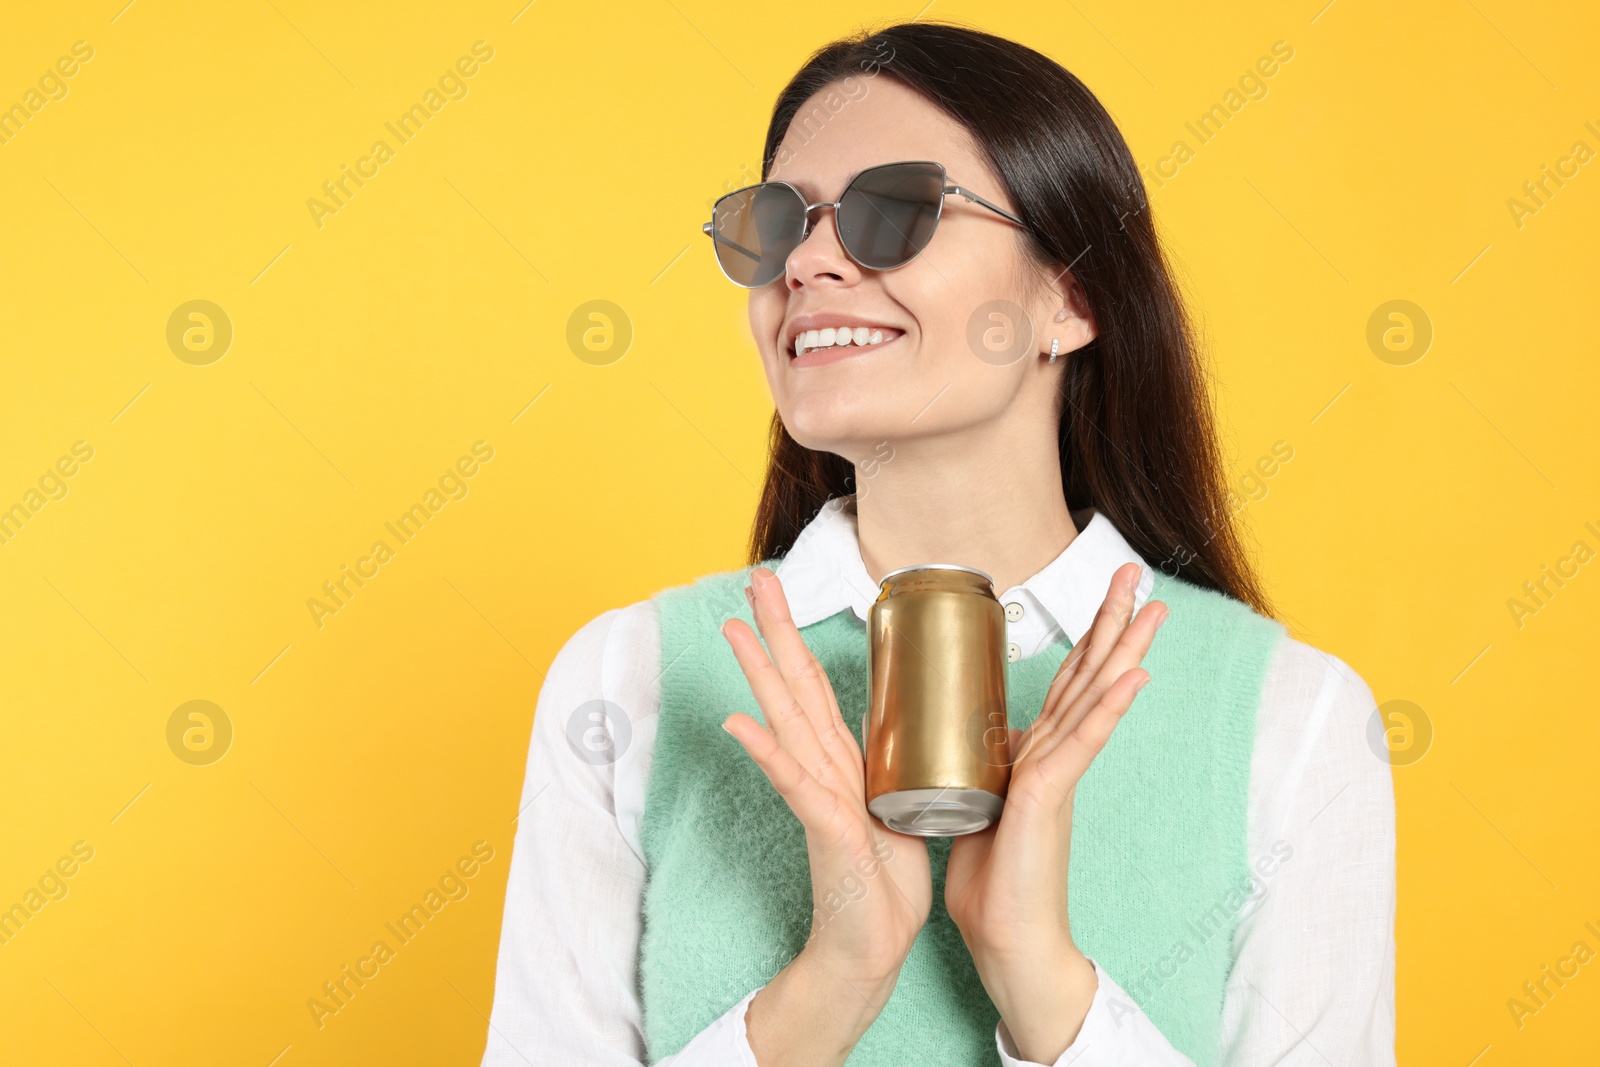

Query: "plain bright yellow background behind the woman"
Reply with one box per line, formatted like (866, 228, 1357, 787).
(0, 0, 1600, 1067)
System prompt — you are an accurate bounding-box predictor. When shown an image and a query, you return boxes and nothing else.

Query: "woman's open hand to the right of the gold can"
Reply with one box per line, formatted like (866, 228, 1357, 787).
(944, 563, 1168, 1064)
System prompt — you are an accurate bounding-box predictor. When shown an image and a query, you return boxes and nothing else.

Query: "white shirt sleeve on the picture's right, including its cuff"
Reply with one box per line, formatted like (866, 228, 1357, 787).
(995, 638, 1395, 1067)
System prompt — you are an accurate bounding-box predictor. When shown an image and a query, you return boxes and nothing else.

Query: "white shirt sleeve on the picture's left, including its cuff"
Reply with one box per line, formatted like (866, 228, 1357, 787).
(483, 601, 755, 1067)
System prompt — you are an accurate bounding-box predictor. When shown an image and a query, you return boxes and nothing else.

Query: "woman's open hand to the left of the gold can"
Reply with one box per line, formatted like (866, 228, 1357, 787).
(722, 566, 933, 1067)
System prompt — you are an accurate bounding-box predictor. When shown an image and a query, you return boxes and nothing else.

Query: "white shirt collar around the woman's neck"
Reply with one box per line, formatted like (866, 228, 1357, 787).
(773, 496, 1155, 645)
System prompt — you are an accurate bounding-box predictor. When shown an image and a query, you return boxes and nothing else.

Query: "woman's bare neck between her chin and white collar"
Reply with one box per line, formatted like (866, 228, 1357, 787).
(856, 419, 1078, 593)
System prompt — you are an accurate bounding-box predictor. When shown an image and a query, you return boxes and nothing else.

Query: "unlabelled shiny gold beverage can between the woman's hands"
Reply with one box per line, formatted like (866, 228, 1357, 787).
(862, 563, 1011, 837)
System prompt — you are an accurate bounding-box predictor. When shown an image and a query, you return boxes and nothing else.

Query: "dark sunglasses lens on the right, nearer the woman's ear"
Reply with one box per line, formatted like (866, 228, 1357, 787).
(838, 163, 944, 270)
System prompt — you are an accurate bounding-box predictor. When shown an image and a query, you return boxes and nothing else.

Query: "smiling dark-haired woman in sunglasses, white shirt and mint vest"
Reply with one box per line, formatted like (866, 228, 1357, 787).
(483, 24, 1394, 1067)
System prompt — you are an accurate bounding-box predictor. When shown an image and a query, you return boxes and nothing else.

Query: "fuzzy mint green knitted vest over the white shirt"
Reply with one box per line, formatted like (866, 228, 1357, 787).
(638, 560, 1283, 1067)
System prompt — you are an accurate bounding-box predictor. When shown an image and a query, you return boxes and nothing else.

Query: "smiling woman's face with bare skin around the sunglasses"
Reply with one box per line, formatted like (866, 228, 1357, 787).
(750, 77, 1094, 461)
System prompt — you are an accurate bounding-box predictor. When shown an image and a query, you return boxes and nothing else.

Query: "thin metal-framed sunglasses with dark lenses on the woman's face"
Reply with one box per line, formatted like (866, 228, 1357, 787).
(701, 162, 1027, 290)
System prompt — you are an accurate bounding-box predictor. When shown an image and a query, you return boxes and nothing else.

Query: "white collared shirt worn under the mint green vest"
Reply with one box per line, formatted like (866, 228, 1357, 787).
(483, 498, 1395, 1067)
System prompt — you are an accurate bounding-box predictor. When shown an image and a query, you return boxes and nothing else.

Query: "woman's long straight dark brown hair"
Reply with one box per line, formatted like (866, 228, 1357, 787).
(749, 21, 1272, 616)
